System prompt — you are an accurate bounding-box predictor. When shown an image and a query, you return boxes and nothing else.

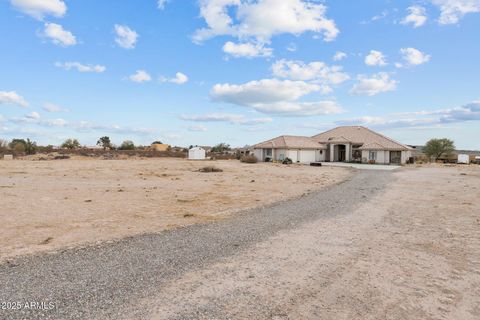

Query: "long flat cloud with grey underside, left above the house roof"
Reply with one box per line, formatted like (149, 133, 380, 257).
(210, 79, 342, 116)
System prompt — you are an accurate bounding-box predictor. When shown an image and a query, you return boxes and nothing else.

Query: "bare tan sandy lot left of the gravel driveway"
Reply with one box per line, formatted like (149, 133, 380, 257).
(0, 159, 351, 260)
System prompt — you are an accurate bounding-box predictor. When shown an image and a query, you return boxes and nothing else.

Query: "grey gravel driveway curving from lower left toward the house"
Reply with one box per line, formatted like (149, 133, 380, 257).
(0, 171, 393, 320)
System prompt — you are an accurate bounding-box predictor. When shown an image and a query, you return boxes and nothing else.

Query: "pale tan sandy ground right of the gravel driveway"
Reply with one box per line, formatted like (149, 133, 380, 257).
(139, 166, 480, 320)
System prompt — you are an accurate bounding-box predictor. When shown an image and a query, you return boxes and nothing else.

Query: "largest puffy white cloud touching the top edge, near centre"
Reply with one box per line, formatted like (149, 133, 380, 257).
(193, 0, 339, 43)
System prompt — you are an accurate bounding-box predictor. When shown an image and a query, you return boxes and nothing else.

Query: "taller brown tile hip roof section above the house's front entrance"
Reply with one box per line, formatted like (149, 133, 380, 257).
(312, 126, 412, 150)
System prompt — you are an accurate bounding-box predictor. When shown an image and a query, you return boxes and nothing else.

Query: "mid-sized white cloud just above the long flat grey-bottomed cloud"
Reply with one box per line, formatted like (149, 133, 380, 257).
(272, 60, 350, 88)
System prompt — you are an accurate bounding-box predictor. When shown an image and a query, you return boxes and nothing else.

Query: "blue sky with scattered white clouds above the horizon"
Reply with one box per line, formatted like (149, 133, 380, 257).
(0, 0, 480, 149)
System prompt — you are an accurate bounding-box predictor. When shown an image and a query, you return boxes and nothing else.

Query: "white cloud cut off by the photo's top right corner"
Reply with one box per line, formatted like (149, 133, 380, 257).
(430, 0, 480, 25)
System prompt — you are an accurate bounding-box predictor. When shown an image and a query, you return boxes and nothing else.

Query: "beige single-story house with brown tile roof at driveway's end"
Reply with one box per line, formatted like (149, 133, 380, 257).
(253, 126, 413, 164)
